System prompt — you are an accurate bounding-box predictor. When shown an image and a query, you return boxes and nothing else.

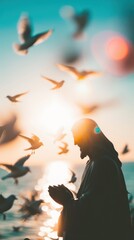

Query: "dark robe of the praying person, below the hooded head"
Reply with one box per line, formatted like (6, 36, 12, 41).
(58, 156, 132, 240)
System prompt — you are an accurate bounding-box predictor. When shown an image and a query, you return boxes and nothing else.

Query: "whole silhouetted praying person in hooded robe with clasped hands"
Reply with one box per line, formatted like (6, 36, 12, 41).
(48, 118, 132, 240)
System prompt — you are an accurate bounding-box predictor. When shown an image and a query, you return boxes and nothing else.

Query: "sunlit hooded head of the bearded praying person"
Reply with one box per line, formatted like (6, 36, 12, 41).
(72, 118, 118, 163)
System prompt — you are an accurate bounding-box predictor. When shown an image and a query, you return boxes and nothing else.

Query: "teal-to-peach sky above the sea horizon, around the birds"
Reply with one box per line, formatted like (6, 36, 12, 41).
(0, 0, 134, 165)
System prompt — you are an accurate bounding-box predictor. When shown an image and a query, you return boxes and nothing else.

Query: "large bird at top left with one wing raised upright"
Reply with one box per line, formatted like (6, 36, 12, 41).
(13, 15, 53, 55)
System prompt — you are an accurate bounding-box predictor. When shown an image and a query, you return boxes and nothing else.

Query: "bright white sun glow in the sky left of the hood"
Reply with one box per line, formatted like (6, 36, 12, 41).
(31, 96, 74, 134)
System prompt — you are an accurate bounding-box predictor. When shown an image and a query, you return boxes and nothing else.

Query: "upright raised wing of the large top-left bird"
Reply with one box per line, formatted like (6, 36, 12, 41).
(18, 15, 32, 42)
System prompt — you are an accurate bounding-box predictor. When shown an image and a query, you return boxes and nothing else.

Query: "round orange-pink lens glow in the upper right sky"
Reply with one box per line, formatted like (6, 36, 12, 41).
(106, 36, 129, 60)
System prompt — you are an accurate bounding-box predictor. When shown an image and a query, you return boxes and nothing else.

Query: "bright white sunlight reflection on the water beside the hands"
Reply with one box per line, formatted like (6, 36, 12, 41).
(35, 161, 76, 240)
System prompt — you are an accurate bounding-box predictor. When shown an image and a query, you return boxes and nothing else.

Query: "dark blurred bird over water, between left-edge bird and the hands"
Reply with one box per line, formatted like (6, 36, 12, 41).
(21, 199, 44, 221)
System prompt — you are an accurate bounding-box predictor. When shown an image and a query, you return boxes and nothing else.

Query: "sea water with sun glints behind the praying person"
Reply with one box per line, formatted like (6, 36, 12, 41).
(0, 162, 134, 240)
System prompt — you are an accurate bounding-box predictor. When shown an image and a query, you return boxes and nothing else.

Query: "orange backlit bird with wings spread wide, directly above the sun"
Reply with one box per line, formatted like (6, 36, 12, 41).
(57, 64, 101, 80)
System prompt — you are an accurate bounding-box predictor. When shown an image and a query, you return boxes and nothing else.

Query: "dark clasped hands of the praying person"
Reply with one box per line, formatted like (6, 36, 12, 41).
(48, 184, 74, 206)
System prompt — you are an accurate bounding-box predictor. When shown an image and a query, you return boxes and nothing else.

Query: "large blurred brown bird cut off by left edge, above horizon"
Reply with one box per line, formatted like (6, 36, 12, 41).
(0, 114, 21, 145)
